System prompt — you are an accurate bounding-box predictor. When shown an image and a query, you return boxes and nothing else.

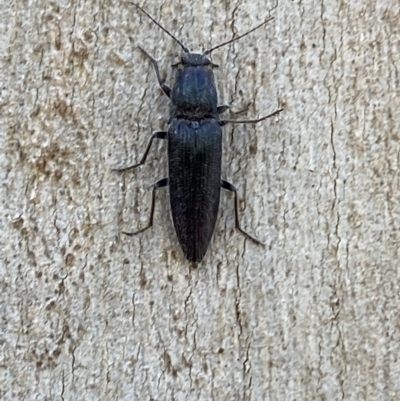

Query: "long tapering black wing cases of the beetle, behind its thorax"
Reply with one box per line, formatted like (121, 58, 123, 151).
(168, 119, 222, 262)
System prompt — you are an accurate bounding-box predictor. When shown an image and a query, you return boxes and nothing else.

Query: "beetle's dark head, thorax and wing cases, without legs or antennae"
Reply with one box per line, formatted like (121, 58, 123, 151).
(168, 53, 222, 262)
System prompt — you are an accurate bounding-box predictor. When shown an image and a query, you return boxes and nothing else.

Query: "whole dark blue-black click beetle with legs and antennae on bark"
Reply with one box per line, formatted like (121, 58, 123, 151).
(115, 3, 283, 263)
